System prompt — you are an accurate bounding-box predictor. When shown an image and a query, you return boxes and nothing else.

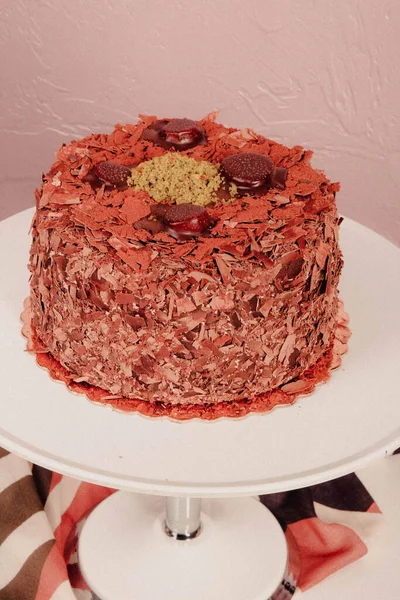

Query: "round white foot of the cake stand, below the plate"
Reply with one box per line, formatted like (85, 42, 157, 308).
(78, 492, 287, 600)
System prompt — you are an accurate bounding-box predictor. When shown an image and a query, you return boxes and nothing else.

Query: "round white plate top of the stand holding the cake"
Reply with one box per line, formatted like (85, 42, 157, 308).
(0, 210, 400, 496)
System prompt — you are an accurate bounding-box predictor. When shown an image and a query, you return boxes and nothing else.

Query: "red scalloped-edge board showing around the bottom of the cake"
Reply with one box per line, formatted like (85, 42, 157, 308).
(21, 298, 351, 421)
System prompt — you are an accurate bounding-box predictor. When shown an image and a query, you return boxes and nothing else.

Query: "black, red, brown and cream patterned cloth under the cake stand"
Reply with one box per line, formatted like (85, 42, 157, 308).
(0, 448, 390, 600)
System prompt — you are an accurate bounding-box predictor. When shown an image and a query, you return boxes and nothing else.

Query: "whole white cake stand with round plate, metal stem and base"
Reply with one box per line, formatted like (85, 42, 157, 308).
(0, 210, 400, 600)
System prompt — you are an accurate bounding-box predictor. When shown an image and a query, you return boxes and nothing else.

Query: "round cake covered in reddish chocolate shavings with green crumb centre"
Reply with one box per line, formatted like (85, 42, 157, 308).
(30, 114, 342, 405)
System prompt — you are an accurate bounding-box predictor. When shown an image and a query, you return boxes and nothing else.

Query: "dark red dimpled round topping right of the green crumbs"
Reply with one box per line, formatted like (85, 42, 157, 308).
(222, 152, 274, 188)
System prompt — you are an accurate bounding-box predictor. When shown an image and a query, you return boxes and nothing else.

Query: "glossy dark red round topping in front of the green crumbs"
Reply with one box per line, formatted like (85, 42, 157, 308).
(164, 204, 213, 237)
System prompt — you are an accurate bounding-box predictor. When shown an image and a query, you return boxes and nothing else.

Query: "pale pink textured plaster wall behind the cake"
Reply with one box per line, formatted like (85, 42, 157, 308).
(0, 0, 400, 244)
